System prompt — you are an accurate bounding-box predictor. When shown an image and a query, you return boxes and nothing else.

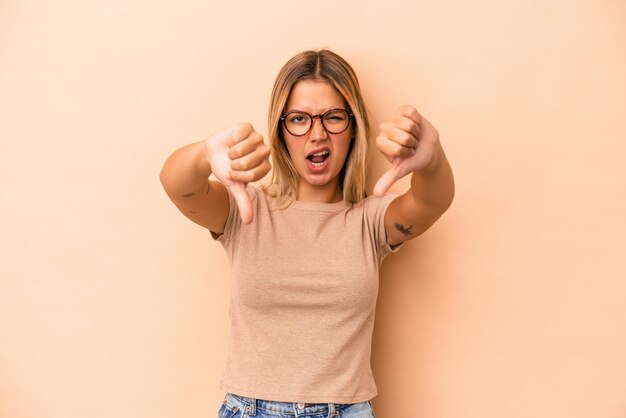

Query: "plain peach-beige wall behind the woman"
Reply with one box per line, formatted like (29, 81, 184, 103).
(0, 0, 626, 418)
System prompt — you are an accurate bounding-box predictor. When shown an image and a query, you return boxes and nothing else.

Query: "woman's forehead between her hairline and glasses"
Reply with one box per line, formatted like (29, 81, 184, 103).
(287, 80, 346, 113)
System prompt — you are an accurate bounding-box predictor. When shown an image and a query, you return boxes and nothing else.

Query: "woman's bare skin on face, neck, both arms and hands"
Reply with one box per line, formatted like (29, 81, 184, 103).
(160, 84, 454, 245)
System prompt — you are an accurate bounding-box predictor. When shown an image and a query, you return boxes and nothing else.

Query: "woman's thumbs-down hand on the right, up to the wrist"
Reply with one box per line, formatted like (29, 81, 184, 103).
(374, 105, 440, 197)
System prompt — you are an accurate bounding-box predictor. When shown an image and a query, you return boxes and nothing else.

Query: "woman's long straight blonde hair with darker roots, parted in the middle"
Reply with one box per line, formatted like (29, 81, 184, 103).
(264, 49, 370, 206)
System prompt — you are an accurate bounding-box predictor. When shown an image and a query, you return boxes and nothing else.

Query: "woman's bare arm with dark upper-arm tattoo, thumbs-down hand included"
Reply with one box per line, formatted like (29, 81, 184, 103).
(374, 106, 454, 245)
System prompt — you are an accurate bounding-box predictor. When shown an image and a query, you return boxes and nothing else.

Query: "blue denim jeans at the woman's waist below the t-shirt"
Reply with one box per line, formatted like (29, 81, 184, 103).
(218, 393, 376, 418)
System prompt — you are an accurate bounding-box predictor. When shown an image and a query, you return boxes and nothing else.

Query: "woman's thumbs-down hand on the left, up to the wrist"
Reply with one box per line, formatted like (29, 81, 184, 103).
(205, 123, 271, 224)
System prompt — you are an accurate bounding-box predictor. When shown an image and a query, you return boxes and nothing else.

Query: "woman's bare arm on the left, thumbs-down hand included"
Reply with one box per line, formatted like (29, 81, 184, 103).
(160, 124, 270, 234)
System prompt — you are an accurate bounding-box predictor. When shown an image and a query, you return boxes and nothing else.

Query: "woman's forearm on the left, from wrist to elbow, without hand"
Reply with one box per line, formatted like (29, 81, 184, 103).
(159, 141, 211, 201)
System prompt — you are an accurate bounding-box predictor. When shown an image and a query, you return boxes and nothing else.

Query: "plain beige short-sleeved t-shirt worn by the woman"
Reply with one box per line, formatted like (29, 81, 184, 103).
(214, 185, 400, 403)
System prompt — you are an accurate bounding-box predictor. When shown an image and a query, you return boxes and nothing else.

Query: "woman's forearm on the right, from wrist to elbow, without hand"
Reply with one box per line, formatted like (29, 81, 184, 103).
(410, 143, 454, 217)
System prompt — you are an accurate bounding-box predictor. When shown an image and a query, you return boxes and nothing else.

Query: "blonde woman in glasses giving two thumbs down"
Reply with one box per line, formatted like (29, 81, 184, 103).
(161, 50, 454, 418)
